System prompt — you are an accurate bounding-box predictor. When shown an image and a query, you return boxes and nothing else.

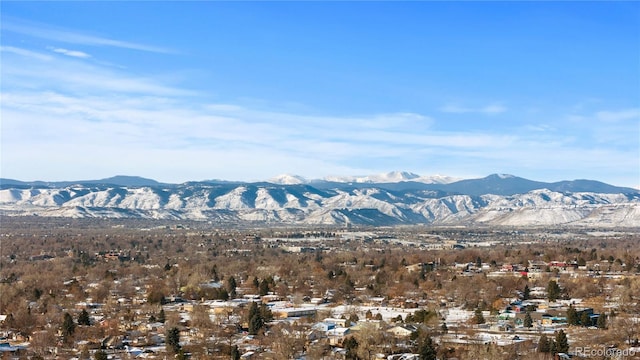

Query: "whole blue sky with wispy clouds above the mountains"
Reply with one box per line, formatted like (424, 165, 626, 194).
(0, 1, 640, 188)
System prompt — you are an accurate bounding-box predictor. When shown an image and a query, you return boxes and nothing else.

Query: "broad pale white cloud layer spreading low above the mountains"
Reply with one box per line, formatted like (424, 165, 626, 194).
(0, 35, 638, 185)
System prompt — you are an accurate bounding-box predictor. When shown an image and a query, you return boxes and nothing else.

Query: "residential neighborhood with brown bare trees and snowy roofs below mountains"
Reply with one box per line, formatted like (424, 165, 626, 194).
(0, 218, 640, 359)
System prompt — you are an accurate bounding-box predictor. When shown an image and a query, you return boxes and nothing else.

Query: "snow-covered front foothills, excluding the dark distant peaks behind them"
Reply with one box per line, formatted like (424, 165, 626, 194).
(0, 184, 640, 226)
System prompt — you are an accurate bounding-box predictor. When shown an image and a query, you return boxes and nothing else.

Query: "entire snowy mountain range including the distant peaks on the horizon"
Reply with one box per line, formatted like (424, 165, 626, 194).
(0, 172, 640, 227)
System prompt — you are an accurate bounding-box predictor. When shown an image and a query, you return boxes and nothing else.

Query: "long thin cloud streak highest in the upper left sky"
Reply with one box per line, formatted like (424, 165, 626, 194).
(1, 17, 175, 53)
